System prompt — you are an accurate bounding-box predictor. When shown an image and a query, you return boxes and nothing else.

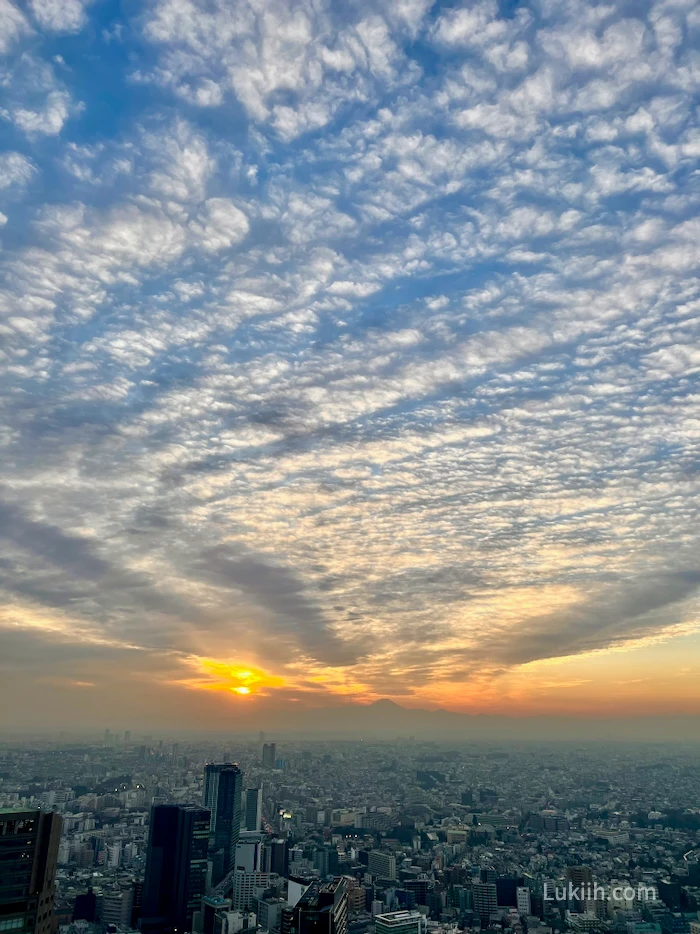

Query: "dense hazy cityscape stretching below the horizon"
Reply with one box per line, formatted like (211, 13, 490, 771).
(0, 730, 700, 934)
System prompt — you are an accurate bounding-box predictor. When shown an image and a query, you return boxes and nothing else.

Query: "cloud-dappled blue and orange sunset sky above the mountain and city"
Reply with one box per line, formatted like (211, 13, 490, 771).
(0, 0, 700, 729)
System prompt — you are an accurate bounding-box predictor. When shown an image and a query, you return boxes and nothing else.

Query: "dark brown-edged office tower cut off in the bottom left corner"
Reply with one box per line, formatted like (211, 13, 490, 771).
(0, 808, 61, 934)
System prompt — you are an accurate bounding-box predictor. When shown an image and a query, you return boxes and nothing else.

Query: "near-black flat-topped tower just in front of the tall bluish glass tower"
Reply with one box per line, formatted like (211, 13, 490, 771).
(141, 804, 209, 934)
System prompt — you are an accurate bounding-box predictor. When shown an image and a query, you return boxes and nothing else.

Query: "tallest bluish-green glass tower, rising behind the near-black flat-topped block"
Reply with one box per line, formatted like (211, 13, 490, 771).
(204, 762, 243, 886)
